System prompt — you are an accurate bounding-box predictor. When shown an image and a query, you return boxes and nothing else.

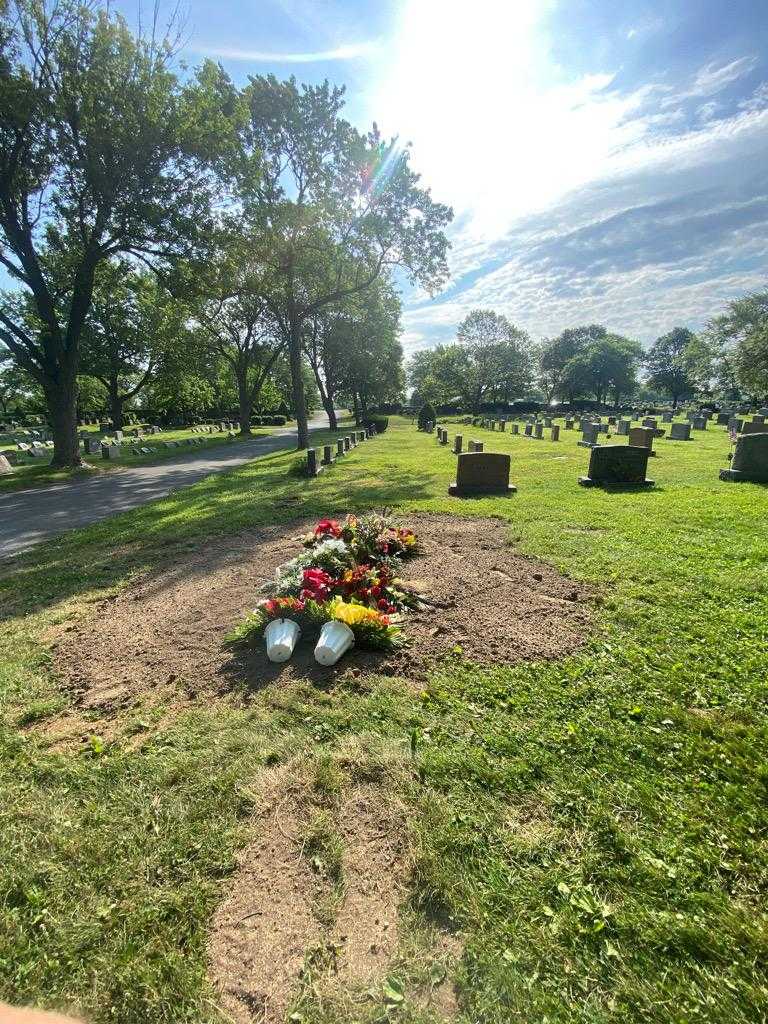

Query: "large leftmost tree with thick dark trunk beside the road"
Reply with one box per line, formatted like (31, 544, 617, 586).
(0, 0, 225, 467)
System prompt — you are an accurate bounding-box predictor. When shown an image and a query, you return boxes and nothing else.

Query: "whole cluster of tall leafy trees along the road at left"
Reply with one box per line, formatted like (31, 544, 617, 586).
(0, 0, 453, 467)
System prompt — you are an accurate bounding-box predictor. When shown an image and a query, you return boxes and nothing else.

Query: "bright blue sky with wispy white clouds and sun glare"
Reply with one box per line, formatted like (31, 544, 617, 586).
(131, 0, 768, 350)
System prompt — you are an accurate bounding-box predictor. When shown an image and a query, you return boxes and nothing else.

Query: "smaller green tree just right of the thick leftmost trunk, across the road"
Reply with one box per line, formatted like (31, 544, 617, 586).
(80, 259, 184, 430)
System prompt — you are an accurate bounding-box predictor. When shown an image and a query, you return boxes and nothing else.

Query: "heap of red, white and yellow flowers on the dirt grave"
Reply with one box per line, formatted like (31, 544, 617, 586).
(225, 514, 418, 650)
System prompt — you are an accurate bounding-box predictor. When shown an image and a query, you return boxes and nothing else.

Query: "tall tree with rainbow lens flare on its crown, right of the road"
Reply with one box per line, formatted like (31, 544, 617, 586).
(241, 76, 453, 447)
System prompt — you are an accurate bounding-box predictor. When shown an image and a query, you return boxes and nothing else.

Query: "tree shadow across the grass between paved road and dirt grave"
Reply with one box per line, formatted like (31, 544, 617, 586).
(0, 458, 433, 627)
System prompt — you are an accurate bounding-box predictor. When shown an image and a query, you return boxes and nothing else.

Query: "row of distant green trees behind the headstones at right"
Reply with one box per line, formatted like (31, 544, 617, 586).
(408, 291, 768, 413)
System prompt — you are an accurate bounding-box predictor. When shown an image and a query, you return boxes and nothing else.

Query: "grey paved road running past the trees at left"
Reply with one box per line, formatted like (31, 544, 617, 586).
(0, 414, 335, 558)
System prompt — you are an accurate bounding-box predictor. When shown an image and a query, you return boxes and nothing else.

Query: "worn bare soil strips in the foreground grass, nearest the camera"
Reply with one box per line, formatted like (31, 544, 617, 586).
(208, 763, 462, 1024)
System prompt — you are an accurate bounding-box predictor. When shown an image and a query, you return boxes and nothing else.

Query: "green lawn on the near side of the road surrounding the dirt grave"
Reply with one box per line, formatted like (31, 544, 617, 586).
(0, 419, 768, 1024)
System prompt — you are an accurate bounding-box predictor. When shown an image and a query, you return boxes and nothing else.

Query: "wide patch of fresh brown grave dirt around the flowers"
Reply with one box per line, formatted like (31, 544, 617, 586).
(54, 515, 591, 709)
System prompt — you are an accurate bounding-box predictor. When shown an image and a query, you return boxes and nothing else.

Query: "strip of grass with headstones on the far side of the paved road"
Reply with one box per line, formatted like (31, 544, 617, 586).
(0, 424, 282, 495)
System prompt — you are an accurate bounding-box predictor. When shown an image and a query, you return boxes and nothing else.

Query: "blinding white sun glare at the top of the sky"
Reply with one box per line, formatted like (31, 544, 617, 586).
(373, 0, 635, 234)
